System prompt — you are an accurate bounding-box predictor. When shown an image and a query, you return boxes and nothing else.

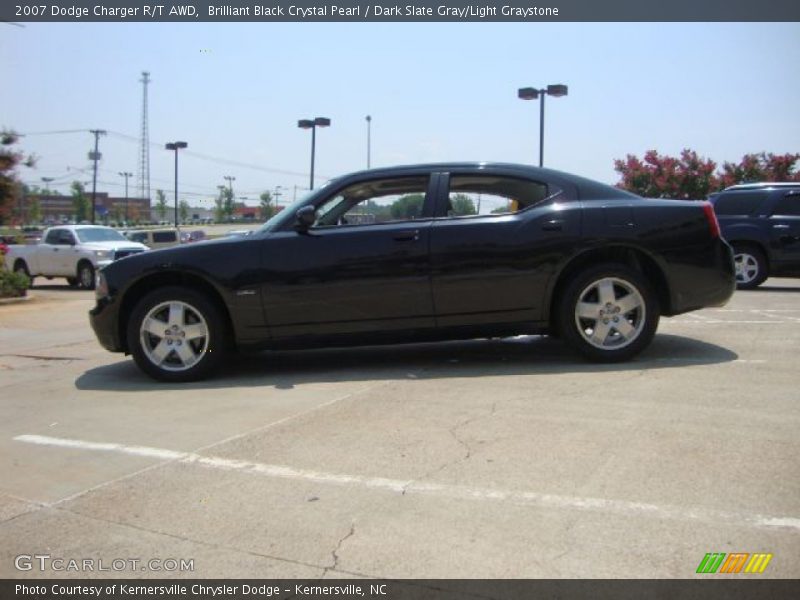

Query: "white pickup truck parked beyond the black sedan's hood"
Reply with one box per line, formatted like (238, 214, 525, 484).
(5, 225, 147, 290)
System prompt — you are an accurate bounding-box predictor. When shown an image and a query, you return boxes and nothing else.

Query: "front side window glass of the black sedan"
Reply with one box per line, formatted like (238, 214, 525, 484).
(314, 176, 428, 227)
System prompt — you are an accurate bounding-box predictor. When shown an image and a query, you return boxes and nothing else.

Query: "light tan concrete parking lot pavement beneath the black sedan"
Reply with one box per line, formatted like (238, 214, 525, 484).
(0, 279, 800, 578)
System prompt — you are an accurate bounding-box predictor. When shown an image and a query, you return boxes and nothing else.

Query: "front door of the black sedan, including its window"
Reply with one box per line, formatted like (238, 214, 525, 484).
(262, 175, 435, 339)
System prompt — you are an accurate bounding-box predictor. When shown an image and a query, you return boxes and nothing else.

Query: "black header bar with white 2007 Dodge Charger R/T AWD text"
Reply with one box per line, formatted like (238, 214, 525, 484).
(0, 0, 800, 23)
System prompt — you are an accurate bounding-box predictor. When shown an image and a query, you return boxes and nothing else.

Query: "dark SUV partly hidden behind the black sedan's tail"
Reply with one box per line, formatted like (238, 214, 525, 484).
(709, 182, 800, 290)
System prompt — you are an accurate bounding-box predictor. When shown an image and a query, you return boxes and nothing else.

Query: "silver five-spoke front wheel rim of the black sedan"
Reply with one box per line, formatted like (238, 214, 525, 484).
(139, 300, 209, 371)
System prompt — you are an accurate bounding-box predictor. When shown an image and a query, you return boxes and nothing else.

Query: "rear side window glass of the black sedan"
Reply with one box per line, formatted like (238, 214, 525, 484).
(447, 175, 561, 217)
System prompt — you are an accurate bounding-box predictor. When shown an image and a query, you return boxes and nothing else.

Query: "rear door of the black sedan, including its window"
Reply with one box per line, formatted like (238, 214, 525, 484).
(431, 171, 580, 327)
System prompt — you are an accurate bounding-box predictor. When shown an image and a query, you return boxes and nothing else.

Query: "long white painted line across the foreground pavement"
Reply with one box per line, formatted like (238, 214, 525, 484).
(14, 435, 800, 532)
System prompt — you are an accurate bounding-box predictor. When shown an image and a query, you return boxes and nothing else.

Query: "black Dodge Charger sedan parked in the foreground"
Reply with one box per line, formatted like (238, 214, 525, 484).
(90, 163, 735, 381)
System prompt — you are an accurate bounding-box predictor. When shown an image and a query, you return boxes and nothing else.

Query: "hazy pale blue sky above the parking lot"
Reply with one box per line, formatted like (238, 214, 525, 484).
(0, 23, 800, 208)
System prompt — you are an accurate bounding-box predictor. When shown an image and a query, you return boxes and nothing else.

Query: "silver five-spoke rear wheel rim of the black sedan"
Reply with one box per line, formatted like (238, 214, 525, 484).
(575, 277, 646, 350)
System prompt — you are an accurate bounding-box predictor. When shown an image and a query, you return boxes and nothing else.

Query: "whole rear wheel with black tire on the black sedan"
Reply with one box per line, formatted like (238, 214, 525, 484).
(557, 263, 660, 362)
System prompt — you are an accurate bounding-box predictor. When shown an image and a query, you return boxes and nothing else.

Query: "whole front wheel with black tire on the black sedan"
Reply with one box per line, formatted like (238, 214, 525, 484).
(127, 286, 230, 383)
